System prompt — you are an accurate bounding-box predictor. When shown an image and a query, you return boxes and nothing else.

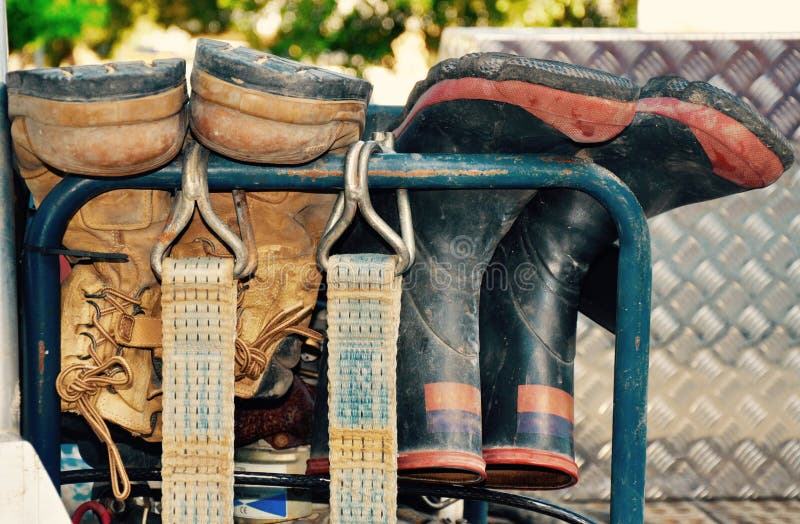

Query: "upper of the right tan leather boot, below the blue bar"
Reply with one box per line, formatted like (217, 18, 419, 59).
(172, 191, 335, 398)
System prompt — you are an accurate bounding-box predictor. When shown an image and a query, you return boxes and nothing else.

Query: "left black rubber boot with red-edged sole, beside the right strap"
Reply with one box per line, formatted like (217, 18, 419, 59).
(308, 53, 637, 483)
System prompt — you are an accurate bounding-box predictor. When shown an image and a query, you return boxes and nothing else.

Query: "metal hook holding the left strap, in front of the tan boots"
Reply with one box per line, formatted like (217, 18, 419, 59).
(150, 142, 253, 278)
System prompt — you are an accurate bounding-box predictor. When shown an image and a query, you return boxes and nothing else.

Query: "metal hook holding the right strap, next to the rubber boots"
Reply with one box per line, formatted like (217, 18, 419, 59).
(317, 141, 415, 274)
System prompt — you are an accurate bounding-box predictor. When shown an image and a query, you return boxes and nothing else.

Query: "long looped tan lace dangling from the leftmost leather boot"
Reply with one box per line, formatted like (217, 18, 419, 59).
(56, 288, 147, 500)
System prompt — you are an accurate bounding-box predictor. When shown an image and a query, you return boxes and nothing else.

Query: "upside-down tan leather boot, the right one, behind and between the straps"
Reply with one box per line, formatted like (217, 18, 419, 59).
(172, 39, 372, 398)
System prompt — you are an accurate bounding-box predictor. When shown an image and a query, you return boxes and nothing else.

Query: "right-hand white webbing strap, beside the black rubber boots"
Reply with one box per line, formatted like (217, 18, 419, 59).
(327, 254, 402, 524)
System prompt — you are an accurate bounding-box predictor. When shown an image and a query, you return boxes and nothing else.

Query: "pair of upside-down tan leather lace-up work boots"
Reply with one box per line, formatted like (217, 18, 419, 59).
(8, 39, 372, 498)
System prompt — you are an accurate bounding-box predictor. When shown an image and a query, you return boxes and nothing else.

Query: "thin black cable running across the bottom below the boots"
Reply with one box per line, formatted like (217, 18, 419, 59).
(61, 469, 594, 524)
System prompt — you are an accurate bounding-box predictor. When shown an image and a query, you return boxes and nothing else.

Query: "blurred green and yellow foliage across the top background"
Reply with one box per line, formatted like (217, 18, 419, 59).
(8, 0, 636, 69)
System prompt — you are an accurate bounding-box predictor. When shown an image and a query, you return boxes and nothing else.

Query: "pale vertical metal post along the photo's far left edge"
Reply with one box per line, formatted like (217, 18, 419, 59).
(0, 0, 19, 436)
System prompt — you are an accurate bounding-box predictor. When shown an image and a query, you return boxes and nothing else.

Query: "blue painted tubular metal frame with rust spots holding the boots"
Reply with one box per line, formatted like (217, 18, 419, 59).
(22, 133, 651, 523)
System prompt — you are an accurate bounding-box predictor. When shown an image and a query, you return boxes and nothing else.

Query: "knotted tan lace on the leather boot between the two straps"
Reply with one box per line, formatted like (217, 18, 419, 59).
(236, 294, 322, 380)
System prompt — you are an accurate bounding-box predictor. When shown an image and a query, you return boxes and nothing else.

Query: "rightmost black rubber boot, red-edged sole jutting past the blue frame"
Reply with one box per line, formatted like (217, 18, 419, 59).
(480, 77, 793, 489)
